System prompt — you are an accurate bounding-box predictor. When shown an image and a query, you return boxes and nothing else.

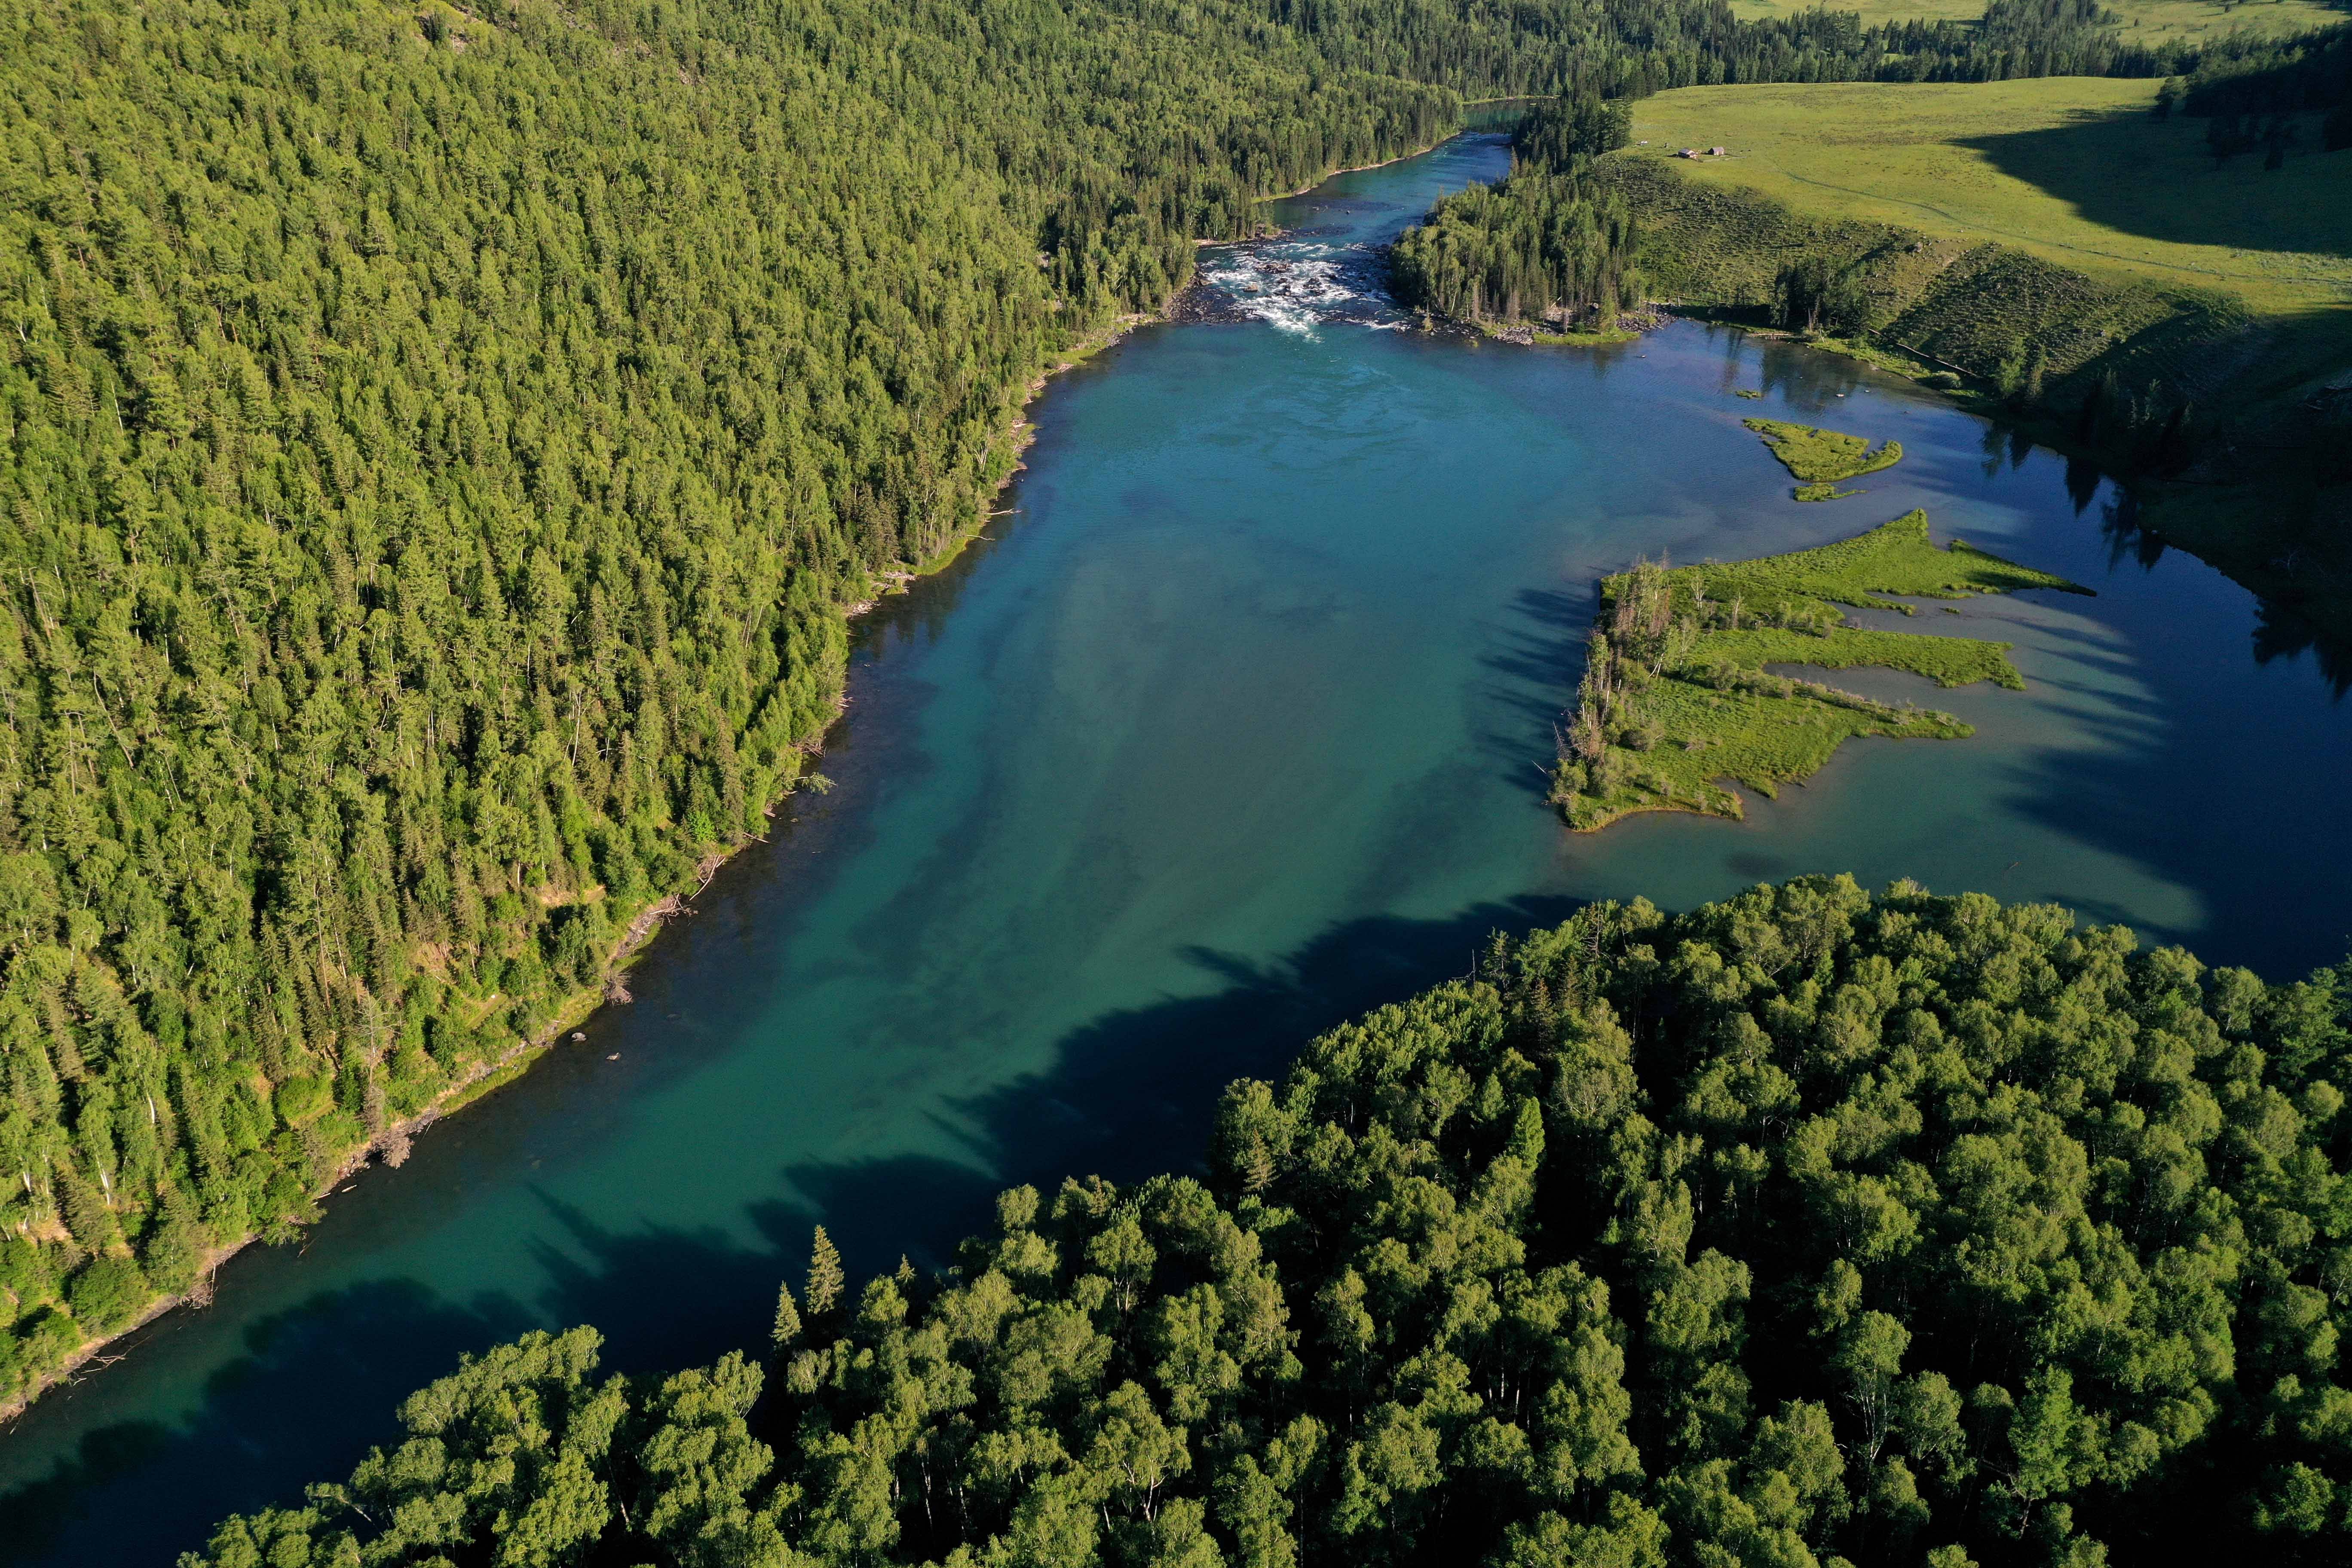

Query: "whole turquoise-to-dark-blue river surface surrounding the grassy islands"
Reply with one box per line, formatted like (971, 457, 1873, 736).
(0, 139, 2352, 1563)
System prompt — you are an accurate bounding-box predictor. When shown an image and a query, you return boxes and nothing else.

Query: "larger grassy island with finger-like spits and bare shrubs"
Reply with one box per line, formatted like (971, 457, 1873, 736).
(1553, 512, 2091, 832)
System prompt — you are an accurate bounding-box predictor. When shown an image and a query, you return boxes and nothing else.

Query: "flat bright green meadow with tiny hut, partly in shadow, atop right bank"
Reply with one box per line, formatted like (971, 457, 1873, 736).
(1635, 77, 2352, 315)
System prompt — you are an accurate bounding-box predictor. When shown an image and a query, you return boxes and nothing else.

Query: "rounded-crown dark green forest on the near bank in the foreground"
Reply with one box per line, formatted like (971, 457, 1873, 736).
(184, 877, 2352, 1568)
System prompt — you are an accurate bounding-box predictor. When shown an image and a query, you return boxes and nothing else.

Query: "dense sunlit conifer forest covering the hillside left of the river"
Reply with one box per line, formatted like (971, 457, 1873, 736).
(0, 0, 2089, 1411)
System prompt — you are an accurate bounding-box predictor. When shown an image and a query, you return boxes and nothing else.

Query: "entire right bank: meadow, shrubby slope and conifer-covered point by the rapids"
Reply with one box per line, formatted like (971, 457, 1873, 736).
(1397, 15, 2352, 649)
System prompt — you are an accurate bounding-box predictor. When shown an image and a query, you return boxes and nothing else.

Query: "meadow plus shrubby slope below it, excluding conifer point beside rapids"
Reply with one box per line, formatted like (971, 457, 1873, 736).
(1602, 77, 2352, 658)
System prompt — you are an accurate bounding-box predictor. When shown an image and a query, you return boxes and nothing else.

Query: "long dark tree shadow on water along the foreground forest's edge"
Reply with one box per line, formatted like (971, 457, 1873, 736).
(0, 898, 1576, 1568)
